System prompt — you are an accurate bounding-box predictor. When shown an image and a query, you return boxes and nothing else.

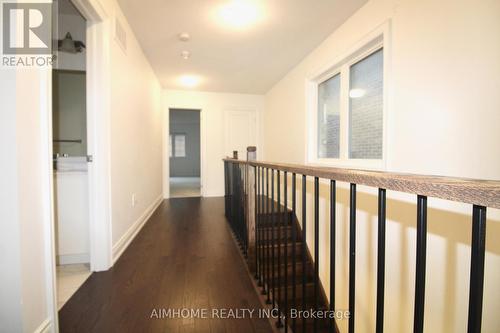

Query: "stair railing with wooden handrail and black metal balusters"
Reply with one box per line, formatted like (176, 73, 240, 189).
(224, 158, 494, 333)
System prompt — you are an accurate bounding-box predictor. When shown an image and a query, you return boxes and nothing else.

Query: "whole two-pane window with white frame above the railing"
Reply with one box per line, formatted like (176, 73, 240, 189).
(308, 36, 385, 167)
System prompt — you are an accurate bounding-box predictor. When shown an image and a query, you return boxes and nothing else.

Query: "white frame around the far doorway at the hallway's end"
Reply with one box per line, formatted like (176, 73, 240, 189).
(163, 105, 206, 199)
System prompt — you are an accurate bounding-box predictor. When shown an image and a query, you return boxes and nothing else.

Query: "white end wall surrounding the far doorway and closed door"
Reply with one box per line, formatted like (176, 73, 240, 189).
(163, 90, 264, 198)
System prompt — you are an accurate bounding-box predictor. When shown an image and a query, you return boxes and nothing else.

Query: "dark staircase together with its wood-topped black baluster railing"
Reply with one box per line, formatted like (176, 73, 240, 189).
(224, 157, 500, 333)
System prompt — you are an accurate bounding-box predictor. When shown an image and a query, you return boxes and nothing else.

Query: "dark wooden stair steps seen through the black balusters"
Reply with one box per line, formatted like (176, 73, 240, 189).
(256, 196, 338, 332)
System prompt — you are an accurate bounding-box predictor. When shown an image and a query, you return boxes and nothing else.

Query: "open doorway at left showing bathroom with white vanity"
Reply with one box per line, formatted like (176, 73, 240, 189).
(52, 0, 91, 309)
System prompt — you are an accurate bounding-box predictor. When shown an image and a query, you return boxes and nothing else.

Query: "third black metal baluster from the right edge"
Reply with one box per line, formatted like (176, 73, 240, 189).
(375, 188, 386, 333)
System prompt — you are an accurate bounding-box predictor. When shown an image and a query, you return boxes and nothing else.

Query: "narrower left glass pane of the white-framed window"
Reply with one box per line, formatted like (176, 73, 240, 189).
(318, 74, 340, 158)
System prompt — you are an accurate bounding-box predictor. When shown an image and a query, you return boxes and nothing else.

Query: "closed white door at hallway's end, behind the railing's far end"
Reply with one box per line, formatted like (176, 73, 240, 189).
(225, 110, 257, 160)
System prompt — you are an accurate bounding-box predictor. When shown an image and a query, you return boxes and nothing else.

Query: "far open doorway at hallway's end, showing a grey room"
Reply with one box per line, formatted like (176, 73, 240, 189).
(169, 109, 201, 198)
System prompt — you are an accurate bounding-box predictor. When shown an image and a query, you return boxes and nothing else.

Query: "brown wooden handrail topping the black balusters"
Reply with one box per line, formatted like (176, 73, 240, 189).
(224, 158, 500, 209)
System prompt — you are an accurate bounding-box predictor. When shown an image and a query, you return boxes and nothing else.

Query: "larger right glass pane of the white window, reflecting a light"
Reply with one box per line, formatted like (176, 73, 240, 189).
(349, 49, 384, 159)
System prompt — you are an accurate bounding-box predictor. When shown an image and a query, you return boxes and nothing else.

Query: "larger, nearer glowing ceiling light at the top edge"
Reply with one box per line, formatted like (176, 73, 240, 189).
(215, 0, 264, 29)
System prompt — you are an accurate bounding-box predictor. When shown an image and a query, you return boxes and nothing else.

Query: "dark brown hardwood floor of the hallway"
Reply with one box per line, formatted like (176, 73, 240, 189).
(59, 198, 272, 333)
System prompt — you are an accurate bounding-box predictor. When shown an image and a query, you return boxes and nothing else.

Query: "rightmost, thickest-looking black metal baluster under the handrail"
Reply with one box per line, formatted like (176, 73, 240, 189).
(467, 205, 486, 333)
